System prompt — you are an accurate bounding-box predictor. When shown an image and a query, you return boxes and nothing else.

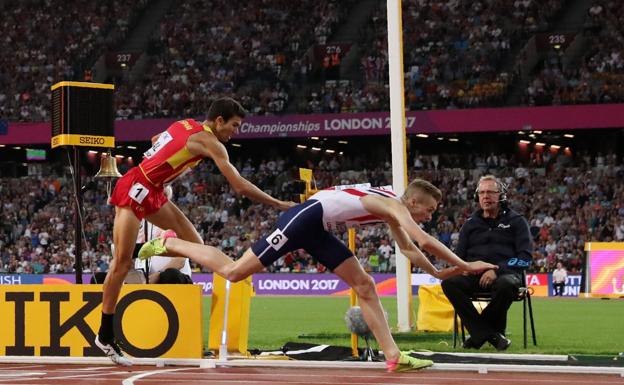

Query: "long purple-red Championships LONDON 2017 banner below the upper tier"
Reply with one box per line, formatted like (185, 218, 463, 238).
(0, 104, 624, 144)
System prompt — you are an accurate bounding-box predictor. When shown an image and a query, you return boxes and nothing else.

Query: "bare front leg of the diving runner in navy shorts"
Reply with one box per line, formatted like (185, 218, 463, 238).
(333, 257, 401, 360)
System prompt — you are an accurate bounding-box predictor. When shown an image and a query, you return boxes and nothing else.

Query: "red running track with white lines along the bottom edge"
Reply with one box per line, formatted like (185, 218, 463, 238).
(0, 364, 624, 385)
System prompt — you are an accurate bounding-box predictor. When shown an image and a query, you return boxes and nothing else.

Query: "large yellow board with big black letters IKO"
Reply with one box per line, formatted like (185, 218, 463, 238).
(0, 285, 203, 358)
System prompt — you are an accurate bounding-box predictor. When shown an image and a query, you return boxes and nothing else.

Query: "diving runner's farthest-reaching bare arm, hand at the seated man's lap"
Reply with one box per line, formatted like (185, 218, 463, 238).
(361, 195, 497, 272)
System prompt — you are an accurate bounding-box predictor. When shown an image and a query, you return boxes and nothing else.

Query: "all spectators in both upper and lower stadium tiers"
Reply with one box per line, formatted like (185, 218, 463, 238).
(0, 0, 624, 280)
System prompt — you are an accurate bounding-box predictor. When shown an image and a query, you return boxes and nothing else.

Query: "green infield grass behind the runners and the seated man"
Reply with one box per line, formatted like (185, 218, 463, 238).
(203, 296, 624, 355)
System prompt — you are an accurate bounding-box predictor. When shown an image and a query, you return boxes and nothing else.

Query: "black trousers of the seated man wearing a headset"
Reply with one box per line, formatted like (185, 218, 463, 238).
(442, 274, 522, 342)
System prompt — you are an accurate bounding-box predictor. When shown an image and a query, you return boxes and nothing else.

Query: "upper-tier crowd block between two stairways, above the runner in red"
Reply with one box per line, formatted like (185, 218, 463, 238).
(117, 0, 355, 119)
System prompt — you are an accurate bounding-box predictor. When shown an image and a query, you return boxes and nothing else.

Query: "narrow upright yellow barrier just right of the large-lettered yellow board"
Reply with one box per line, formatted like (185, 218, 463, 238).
(208, 274, 253, 355)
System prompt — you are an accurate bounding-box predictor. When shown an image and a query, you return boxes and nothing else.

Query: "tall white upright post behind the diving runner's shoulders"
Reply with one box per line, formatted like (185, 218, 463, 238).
(386, 0, 412, 332)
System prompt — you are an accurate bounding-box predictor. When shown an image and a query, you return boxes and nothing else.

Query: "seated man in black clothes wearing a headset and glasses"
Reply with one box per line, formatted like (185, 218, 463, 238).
(442, 175, 533, 350)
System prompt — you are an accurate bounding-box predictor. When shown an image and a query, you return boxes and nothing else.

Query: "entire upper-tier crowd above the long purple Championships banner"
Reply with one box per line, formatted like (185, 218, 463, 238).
(0, 0, 624, 121)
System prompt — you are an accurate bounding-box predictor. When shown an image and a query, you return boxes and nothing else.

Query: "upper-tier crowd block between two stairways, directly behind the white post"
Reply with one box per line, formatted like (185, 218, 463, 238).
(308, 0, 565, 112)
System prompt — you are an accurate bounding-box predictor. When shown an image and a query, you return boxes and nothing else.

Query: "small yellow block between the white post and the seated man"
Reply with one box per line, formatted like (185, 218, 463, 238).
(416, 285, 454, 332)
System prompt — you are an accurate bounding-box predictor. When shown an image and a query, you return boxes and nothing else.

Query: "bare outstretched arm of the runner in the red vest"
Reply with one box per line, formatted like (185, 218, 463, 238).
(187, 133, 295, 210)
